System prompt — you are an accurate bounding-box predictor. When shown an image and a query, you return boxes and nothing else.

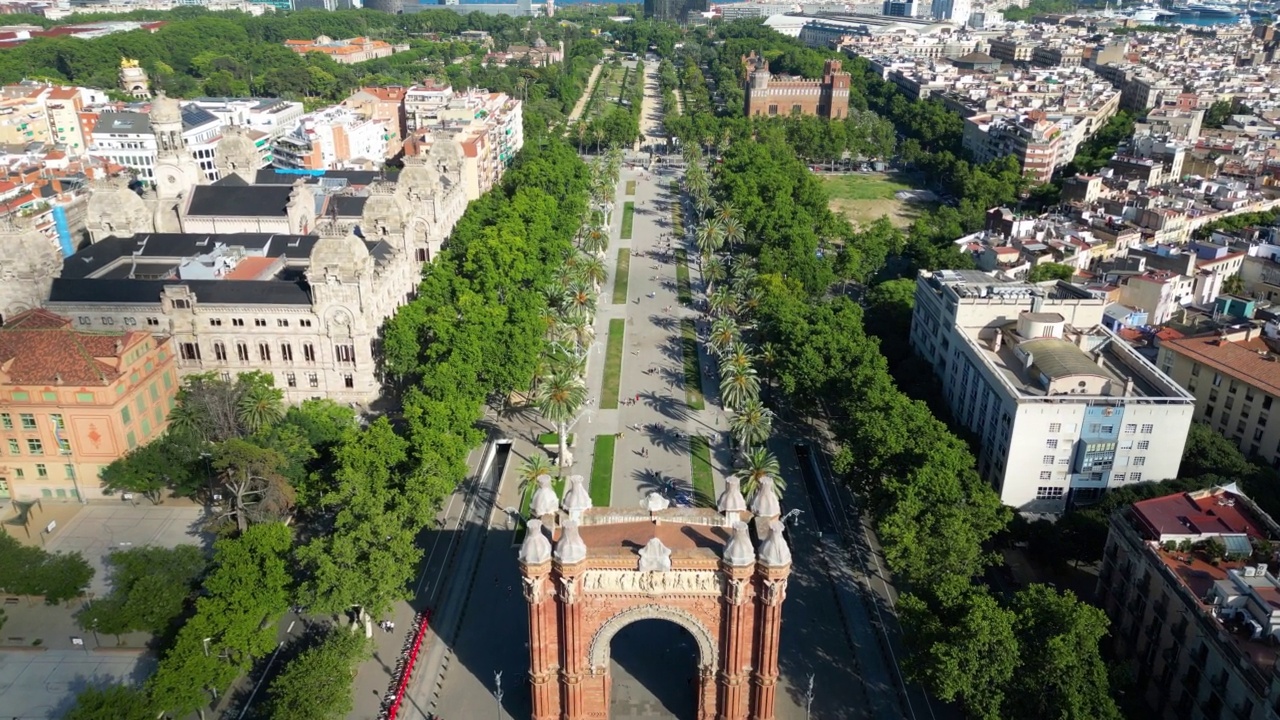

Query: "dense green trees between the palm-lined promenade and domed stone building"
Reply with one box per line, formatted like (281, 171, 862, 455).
(62, 128, 591, 720)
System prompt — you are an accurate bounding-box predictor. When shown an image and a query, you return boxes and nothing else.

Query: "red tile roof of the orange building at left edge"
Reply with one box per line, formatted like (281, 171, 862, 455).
(0, 309, 147, 386)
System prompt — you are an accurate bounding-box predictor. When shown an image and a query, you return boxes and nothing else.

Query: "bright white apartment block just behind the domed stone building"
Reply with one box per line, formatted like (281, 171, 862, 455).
(271, 106, 396, 170)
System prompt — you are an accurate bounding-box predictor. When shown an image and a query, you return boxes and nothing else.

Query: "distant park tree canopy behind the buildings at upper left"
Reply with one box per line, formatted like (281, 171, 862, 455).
(0, 8, 603, 122)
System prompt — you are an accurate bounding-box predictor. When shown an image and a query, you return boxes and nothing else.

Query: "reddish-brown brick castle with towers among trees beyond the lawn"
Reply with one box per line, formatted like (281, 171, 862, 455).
(742, 53, 850, 120)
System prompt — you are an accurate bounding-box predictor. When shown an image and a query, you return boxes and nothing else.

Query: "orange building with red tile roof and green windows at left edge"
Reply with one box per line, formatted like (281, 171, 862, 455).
(0, 310, 178, 500)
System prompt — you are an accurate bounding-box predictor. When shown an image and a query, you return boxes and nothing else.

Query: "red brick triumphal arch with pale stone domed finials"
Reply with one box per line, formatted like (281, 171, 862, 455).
(520, 477, 791, 720)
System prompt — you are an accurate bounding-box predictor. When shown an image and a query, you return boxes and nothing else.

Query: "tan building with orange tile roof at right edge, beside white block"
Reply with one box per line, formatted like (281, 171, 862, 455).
(1158, 324, 1280, 468)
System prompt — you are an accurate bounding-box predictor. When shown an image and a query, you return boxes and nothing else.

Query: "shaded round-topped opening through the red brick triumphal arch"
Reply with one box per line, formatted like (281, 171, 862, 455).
(609, 619, 699, 720)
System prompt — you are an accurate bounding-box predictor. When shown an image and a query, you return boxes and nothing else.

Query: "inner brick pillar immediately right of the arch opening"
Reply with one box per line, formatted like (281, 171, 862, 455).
(716, 562, 755, 720)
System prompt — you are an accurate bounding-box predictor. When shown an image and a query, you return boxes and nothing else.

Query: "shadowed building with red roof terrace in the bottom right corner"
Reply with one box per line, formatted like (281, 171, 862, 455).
(1097, 488, 1280, 720)
